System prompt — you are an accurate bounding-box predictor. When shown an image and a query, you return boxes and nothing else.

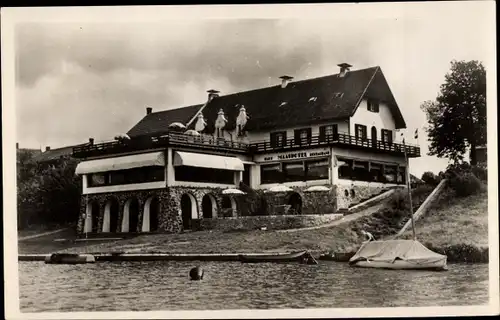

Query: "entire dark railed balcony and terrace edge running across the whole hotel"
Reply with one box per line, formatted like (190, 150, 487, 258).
(73, 132, 420, 158)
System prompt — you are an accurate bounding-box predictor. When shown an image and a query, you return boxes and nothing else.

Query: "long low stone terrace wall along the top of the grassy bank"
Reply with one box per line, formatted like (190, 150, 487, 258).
(196, 214, 342, 231)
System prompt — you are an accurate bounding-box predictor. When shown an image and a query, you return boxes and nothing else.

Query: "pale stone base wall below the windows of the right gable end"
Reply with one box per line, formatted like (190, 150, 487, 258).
(337, 184, 390, 209)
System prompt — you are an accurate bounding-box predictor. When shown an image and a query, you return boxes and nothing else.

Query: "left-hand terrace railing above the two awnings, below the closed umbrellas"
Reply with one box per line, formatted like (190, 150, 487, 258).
(73, 133, 249, 158)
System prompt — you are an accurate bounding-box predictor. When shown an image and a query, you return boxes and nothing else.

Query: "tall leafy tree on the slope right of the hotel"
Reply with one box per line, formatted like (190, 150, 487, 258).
(421, 60, 486, 165)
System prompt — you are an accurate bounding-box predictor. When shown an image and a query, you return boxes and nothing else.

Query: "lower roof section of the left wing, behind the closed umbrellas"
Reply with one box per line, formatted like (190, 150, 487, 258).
(127, 104, 203, 137)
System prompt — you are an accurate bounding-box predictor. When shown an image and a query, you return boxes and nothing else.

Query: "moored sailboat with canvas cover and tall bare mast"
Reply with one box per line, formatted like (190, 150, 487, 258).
(349, 139, 447, 271)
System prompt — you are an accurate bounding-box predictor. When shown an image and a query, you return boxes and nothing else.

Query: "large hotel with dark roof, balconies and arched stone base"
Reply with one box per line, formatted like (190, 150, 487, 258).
(73, 63, 420, 233)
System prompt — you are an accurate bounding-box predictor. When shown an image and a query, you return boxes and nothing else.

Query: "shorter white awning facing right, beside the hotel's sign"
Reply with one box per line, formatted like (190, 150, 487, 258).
(174, 151, 245, 171)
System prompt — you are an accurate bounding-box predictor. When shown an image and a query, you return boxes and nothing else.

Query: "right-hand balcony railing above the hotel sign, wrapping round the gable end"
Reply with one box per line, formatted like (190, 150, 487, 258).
(251, 133, 420, 158)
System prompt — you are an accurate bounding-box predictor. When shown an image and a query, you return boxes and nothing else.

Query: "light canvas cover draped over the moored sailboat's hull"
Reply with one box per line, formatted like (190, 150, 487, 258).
(349, 240, 446, 265)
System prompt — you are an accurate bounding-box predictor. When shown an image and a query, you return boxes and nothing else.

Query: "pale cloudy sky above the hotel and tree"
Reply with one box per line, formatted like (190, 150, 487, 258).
(10, 2, 494, 177)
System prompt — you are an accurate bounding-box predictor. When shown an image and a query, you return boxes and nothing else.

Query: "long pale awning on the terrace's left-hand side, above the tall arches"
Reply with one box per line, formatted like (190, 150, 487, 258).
(75, 152, 165, 174)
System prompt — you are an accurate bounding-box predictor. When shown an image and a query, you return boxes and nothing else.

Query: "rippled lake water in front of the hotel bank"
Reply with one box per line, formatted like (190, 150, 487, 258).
(19, 261, 488, 312)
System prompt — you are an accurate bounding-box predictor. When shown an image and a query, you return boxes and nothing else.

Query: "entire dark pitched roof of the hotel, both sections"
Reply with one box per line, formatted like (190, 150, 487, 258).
(128, 67, 406, 135)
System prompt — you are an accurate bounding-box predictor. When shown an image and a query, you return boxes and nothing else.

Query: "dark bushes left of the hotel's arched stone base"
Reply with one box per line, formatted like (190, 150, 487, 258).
(17, 159, 81, 229)
